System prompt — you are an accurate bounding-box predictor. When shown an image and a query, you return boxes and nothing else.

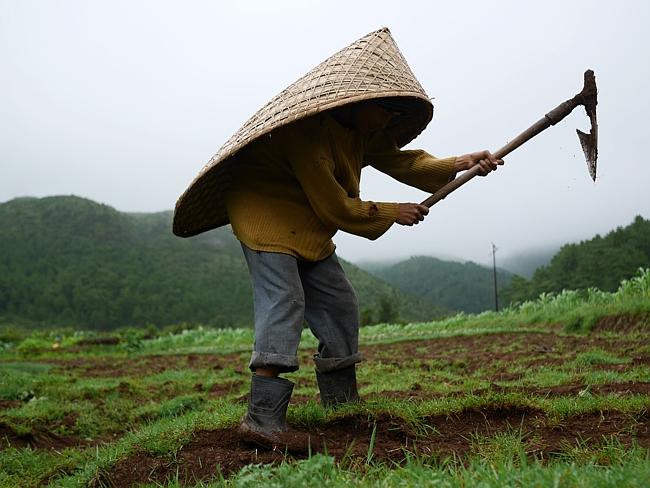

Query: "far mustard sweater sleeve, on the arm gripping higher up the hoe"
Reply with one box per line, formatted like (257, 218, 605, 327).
(364, 133, 456, 193)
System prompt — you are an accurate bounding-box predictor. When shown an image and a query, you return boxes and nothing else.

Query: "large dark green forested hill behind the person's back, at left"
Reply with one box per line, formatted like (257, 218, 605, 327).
(0, 196, 441, 329)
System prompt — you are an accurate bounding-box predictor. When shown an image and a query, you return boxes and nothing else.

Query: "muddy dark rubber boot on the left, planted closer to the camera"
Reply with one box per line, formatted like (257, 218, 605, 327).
(239, 375, 317, 452)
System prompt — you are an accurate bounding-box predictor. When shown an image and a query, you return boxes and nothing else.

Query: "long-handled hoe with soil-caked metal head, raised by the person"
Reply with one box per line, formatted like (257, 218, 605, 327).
(422, 70, 598, 207)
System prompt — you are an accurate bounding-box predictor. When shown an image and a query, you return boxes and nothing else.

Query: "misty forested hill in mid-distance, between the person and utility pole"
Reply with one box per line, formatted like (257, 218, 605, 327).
(362, 256, 512, 313)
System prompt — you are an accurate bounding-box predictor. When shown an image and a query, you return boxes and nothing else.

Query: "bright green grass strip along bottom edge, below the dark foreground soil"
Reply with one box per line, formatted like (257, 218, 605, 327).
(204, 450, 650, 488)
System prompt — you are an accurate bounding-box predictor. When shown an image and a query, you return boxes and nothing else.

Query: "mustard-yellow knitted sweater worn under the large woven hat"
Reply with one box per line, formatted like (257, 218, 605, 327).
(226, 113, 456, 261)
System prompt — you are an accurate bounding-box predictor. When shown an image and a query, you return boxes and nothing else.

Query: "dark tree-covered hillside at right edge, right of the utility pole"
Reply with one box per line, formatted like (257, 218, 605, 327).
(504, 216, 650, 302)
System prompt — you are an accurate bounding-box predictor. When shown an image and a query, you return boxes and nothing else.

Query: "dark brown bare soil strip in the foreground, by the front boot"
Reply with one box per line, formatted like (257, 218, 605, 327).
(96, 405, 650, 486)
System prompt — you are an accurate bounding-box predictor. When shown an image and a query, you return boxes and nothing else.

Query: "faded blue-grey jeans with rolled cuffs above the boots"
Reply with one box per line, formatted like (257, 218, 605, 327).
(242, 244, 362, 373)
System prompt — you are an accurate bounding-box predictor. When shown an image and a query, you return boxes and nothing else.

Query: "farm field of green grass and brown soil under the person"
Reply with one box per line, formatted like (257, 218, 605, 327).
(0, 271, 650, 487)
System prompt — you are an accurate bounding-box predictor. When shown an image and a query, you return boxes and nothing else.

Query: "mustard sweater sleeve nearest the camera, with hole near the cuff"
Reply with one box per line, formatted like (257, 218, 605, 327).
(287, 126, 399, 240)
